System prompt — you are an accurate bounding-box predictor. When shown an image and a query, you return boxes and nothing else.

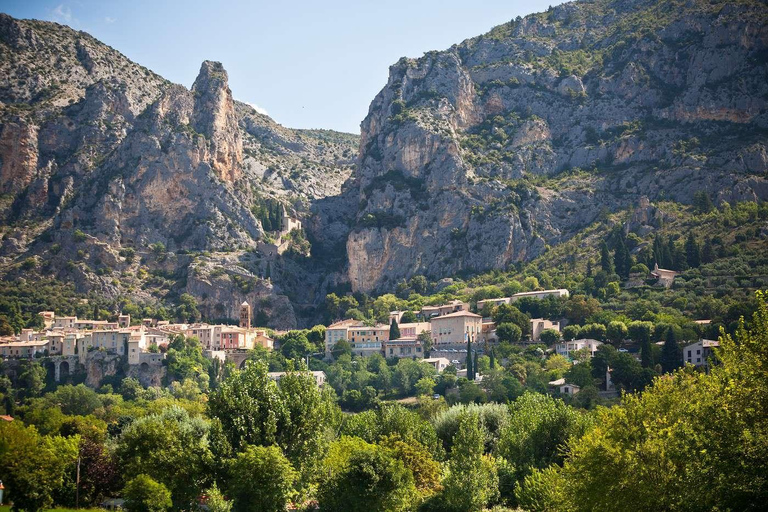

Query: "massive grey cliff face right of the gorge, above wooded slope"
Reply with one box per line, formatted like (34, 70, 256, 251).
(347, 0, 768, 291)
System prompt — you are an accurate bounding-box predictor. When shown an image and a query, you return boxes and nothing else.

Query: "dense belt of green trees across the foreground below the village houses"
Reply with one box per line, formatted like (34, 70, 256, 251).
(0, 292, 768, 511)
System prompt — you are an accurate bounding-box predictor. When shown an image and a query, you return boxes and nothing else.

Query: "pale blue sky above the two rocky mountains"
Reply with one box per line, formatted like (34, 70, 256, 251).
(0, 0, 560, 133)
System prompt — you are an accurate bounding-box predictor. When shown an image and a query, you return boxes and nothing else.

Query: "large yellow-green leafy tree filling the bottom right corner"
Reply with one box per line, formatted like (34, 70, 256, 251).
(550, 293, 768, 511)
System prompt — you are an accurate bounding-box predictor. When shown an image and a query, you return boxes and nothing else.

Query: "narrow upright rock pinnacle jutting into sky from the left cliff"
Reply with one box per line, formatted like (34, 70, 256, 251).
(192, 60, 243, 182)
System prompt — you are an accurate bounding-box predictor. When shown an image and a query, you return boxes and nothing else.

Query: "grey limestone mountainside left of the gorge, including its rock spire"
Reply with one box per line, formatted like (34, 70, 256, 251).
(0, 14, 358, 328)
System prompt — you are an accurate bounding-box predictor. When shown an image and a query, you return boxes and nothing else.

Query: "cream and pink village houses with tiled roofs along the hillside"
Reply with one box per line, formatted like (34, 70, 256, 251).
(0, 289, 717, 394)
